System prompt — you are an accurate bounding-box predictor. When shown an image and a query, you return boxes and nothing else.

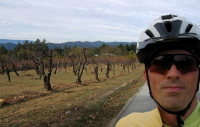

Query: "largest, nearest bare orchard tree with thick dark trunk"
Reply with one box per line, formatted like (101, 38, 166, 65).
(24, 39, 53, 91)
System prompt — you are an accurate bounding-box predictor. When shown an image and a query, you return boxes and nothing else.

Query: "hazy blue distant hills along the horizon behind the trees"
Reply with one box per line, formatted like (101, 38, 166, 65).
(0, 39, 136, 50)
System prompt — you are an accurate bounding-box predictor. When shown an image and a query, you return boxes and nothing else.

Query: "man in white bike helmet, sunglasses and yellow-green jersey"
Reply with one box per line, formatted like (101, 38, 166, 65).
(116, 15, 200, 127)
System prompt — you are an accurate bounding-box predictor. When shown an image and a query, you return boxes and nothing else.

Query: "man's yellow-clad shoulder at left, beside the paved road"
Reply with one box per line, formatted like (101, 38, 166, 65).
(116, 108, 162, 127)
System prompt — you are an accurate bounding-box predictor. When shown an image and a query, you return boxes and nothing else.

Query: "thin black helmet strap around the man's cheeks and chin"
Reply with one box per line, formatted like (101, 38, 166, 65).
(145, 65, 200, 127)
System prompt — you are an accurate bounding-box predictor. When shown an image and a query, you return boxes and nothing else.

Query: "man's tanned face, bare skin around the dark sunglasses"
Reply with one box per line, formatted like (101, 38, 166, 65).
(144, 50, 199, 111)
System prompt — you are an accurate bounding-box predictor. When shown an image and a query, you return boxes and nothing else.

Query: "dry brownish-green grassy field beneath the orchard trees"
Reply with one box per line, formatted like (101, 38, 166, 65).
(0, 65, 144, 127)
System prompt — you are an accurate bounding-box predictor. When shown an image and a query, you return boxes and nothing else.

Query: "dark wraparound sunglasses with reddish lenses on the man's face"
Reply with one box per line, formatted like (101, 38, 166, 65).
(146, 54, 199, 74)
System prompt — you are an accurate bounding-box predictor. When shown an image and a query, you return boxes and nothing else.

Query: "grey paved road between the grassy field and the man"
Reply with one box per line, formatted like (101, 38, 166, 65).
(110, 84, 200, 127)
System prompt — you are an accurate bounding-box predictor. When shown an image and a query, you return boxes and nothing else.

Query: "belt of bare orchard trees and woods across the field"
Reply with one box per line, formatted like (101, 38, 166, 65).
(0, 39, 136, 90)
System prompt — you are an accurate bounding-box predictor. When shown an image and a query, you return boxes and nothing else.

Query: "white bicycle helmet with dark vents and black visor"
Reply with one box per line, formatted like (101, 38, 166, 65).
(136, 14, 200, 63)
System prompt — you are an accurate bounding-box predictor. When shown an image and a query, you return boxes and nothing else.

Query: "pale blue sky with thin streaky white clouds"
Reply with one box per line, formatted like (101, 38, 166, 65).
(0, 0, 200, 43)
